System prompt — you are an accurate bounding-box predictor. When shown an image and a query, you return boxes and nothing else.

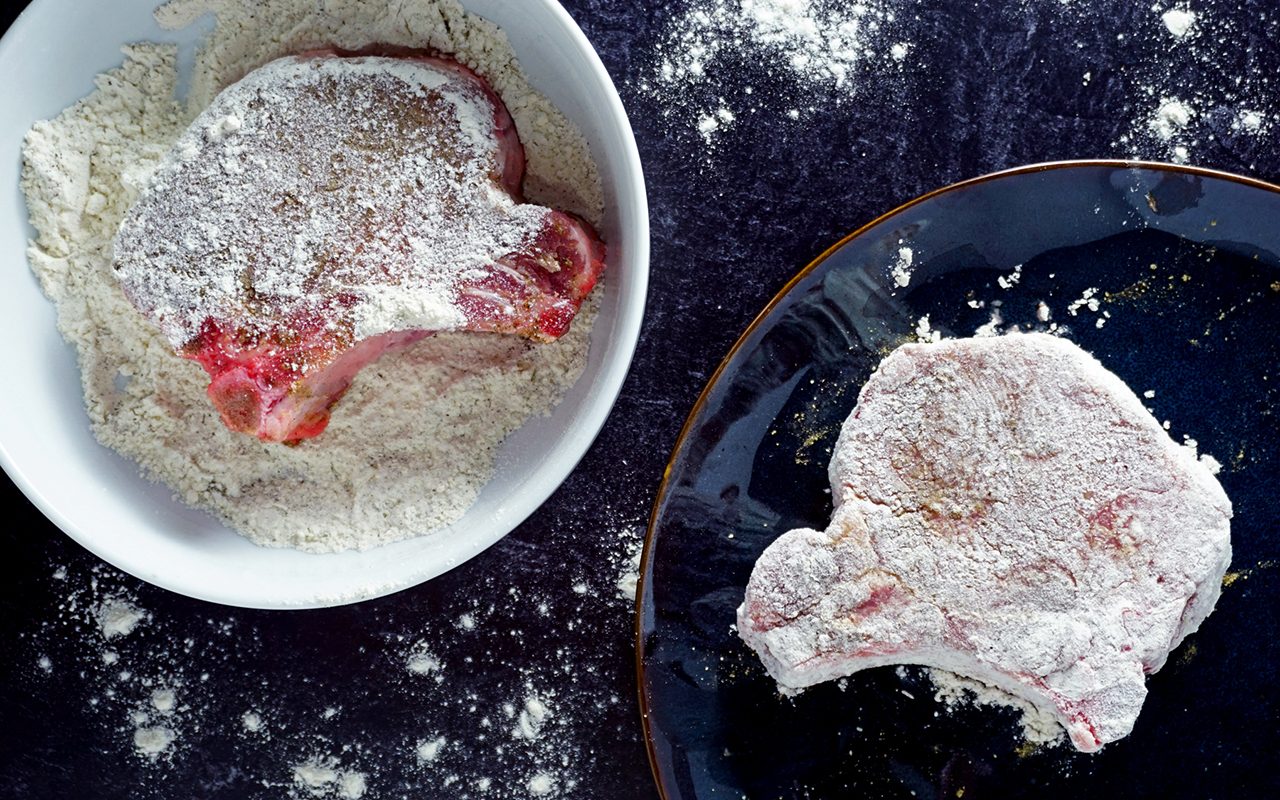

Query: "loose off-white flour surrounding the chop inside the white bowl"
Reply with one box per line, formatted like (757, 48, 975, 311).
(23, 0, 603, 552)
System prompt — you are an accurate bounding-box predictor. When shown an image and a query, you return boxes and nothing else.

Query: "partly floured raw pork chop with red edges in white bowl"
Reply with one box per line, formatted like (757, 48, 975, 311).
(115, 50, 604, 442)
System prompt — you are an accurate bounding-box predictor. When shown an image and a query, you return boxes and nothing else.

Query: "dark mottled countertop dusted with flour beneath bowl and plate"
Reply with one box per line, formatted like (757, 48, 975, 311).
(0, 0, 1280, 800)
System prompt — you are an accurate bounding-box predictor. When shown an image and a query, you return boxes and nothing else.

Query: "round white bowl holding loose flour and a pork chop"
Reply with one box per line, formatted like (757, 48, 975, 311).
(0, 0, 649, 608)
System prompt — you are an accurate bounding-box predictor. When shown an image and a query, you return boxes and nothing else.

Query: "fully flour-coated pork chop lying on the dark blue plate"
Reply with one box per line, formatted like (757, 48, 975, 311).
(737, 334, 1231, 751)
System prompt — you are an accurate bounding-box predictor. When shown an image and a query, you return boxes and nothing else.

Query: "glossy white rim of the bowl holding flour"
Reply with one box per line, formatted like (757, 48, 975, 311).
(0, 0, 650, 609)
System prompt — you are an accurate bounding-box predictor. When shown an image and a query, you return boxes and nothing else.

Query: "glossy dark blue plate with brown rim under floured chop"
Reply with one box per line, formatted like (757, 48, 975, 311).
(637, 163, 1280, 800)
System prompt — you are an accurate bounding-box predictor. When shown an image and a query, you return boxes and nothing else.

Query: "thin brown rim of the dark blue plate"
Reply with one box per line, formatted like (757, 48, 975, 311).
(632, 159, 1280, 800)
